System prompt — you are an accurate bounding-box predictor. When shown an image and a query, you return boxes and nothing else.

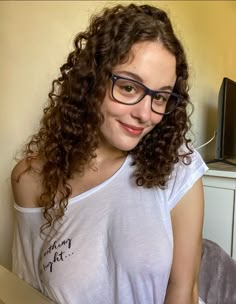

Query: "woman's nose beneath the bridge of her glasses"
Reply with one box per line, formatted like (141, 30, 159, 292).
(131, 95, 152, 122)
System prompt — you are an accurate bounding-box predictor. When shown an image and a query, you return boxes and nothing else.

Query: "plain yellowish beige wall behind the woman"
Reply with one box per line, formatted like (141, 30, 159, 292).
(0, 1, 236, 267)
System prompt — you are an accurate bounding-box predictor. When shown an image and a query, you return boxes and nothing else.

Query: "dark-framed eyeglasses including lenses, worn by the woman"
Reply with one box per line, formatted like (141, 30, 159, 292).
(111, 74, 183, 115)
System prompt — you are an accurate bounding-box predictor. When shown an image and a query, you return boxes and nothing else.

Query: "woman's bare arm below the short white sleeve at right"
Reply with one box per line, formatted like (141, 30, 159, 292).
(166, 179, 204, 304)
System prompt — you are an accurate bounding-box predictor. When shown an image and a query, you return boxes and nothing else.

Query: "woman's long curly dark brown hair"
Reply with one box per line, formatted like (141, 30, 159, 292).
(22, 4, 192, 227)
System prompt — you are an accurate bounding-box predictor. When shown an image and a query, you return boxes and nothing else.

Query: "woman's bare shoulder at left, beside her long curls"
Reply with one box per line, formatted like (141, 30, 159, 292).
(11, 159, 43, 208)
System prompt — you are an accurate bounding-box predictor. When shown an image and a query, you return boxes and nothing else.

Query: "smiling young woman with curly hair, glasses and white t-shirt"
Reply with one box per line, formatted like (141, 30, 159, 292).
(12, 4, 206, 304)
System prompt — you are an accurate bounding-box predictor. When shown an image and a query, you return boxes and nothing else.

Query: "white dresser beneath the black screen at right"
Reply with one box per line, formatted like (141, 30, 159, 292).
(203, 162, 236, 259)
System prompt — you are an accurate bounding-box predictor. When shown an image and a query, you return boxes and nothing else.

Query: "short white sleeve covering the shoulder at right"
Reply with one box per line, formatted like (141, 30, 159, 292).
(166, 150, 208, 210)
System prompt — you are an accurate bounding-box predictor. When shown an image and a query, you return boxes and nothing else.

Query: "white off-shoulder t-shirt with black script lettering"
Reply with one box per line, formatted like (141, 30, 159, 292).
(13, 151, 207, 304)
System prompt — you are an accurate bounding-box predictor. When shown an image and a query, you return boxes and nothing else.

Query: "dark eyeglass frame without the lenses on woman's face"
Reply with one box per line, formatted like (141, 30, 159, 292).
(110, 73, 183, 115)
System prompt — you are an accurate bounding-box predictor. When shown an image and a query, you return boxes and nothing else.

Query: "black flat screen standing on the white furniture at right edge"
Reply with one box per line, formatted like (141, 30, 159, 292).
(215, 77, 236, 165)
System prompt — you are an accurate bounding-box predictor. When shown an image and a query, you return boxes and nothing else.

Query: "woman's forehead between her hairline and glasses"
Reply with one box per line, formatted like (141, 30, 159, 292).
(113, 41, 176, 89)
